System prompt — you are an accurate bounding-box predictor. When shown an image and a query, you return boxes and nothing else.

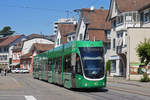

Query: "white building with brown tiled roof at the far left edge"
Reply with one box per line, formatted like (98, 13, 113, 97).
(0, 35, 25, 69)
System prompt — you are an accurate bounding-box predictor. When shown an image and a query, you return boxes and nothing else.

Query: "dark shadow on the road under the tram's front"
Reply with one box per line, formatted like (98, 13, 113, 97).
(72, 88, 109, 93)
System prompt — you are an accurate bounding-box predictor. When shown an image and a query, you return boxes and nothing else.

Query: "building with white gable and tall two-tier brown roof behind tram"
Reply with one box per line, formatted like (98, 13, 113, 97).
(76, 8, 111, 62)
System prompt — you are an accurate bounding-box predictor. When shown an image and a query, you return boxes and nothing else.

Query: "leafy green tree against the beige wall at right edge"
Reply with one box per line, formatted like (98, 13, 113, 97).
(136, 39, 150, 64)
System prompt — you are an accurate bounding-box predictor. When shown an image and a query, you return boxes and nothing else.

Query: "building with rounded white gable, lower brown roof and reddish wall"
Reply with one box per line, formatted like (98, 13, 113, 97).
(20, 34, 54, 72)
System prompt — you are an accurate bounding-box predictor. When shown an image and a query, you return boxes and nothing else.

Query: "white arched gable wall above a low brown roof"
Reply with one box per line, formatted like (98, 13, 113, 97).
(22, 38, 53, 55)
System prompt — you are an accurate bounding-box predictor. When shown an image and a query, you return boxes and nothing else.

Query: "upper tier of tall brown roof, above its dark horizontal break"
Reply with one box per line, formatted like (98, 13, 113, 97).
(81, 8, 111, 29)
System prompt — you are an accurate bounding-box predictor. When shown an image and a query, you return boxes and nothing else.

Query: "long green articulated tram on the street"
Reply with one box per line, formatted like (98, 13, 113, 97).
(33, 41, 106, 89)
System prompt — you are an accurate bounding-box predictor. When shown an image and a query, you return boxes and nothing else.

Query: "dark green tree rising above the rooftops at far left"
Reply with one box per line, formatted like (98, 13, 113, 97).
(0, 26, 15, 37)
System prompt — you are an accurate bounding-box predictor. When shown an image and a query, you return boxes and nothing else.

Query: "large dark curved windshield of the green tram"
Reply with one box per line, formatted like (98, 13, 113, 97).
(79, 47, 104, 79)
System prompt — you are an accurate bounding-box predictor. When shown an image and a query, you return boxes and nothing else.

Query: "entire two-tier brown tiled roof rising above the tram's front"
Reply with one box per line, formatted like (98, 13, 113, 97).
(81, 8, 111, 41)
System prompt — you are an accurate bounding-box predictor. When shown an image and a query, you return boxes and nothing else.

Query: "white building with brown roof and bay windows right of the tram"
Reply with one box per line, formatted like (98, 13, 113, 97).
(107, 0, 150, 77)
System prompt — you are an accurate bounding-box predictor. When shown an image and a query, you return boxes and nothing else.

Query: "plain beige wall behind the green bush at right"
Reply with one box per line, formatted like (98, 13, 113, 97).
(127, 27, 150, 79)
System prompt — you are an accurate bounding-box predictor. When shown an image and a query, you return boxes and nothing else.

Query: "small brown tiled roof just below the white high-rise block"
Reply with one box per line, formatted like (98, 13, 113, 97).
(58, 24, 76, 44)
